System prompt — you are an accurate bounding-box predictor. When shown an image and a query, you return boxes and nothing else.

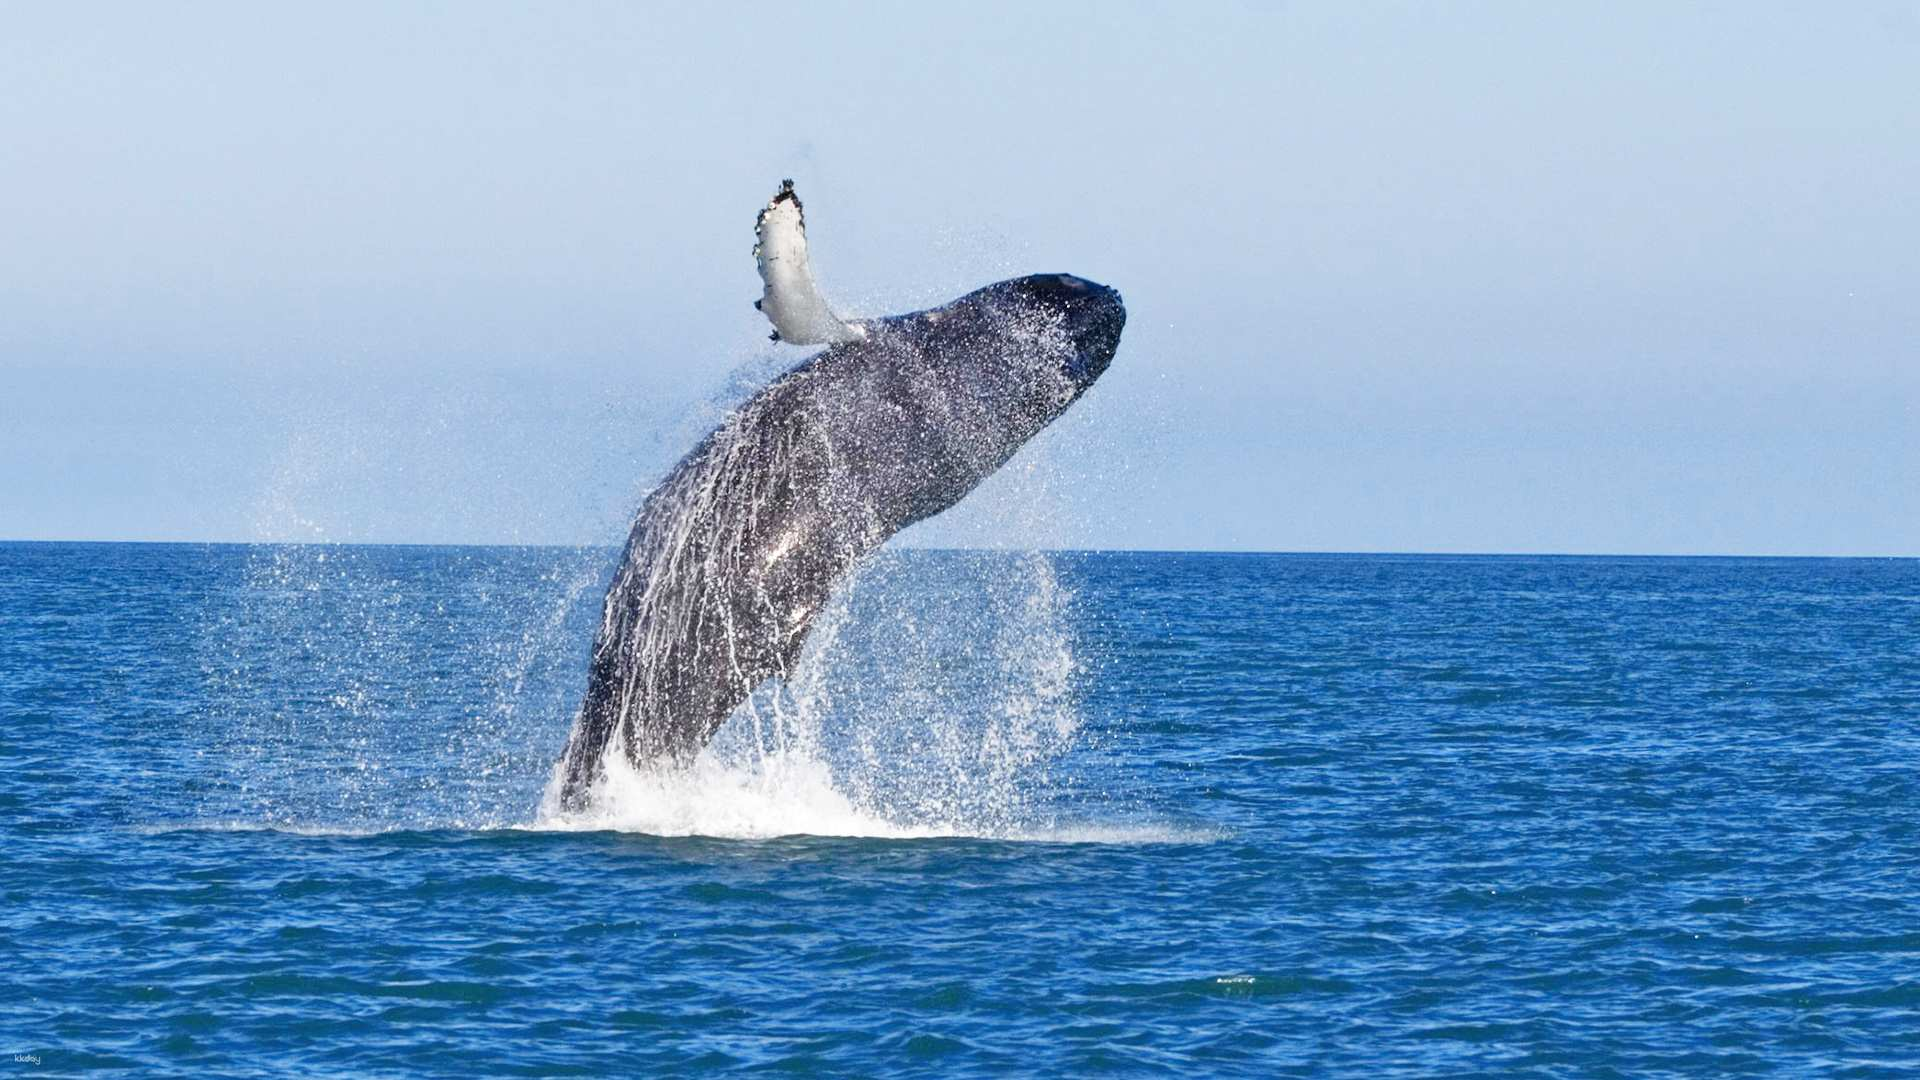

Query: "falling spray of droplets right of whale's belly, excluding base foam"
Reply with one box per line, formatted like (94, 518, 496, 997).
(789, 552, 1083, 834)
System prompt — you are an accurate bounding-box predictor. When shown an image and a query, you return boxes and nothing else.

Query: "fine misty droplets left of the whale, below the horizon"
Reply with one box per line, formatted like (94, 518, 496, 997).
(198, 544, 607, 830)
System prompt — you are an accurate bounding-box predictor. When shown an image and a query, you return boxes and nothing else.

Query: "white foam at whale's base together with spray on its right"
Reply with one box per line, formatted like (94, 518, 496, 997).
(536, 552, 1087, 838)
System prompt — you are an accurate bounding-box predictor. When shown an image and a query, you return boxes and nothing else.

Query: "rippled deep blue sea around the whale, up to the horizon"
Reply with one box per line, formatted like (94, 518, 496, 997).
(0, 544, 1920, 1076)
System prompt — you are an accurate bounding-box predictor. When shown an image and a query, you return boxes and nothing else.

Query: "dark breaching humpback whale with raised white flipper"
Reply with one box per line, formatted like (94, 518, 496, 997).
(557, 181, 1127, 811)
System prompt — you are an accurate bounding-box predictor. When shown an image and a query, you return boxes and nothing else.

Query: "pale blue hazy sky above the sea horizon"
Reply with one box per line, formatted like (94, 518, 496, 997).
(0, 0, 1920, 555)
